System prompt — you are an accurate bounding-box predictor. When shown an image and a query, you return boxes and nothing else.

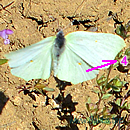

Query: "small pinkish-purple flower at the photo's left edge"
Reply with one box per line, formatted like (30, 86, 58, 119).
(0, 29, 13, 44)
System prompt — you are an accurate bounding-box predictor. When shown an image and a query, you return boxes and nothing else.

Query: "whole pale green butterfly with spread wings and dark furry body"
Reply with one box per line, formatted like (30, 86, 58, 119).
(5, 31, 125, 84)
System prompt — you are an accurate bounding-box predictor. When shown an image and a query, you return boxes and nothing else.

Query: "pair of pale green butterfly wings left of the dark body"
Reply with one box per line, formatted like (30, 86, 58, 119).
(5, 37, 55, 81)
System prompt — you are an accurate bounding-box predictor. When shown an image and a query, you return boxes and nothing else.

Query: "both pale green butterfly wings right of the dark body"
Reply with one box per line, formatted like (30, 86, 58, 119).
(54, 31, 125, 84)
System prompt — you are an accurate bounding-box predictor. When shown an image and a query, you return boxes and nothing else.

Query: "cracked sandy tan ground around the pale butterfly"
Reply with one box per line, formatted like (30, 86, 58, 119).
(0, 0, 130, 130)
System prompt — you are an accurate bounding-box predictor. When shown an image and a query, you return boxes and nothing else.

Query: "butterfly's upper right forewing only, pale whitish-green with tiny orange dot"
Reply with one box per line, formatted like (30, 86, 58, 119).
(66, 31, 125, 68)
